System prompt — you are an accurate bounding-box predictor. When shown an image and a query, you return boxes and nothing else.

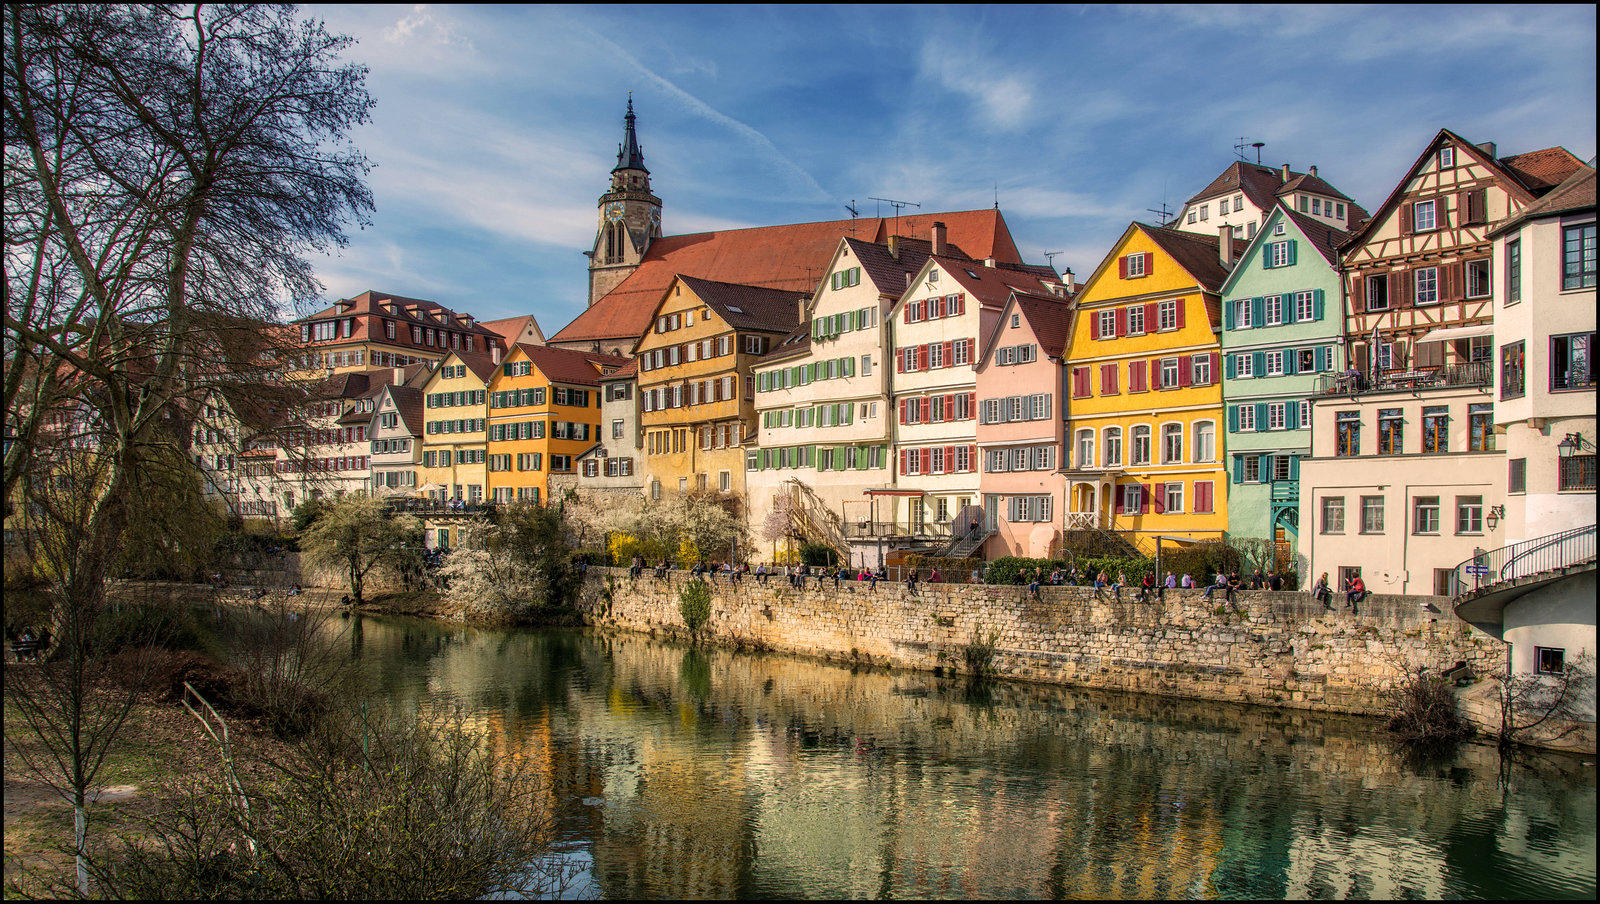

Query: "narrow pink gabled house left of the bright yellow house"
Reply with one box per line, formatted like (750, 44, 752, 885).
(978, 291, 1072, 558)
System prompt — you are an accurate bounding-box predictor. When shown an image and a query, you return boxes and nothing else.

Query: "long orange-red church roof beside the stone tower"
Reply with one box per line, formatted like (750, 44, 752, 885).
(550, 210, 1021, 344)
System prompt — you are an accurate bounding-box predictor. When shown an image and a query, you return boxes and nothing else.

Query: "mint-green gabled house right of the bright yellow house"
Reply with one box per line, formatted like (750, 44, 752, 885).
(1221, 200, 1349, 547)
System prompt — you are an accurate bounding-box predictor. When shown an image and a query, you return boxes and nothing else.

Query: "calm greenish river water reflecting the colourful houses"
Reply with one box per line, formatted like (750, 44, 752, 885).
(334, 618, 1595, 898)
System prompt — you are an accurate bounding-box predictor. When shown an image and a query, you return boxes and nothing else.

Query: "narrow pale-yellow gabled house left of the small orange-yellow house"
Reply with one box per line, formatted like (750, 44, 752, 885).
(418, 352, 494, 504)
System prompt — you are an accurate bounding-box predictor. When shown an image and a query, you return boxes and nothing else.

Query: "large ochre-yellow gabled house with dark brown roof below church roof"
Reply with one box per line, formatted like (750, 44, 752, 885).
(634, 275, 793, 499)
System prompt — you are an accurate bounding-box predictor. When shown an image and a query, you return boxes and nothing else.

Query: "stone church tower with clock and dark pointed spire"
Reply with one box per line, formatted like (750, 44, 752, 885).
(587, 93, 661, 306)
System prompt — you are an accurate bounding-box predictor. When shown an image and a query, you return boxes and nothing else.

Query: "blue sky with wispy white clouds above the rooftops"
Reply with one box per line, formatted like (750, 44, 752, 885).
(302, 5, 1595, 336)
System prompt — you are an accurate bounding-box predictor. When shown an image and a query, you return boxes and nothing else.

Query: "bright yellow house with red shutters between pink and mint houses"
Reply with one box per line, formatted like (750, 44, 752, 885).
(1066, 222, 1245, 552)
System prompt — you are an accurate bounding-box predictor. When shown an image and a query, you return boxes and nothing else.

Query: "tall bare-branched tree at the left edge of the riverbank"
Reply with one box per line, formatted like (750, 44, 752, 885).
(0, 5, 371, 894)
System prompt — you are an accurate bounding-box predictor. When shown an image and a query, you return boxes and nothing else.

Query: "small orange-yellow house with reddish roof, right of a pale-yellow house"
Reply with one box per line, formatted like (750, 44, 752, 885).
(485, 344, 627, 504)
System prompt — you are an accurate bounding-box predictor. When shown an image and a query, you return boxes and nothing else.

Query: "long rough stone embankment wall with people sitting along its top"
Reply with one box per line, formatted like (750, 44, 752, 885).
(582, 568, 1504, 715)
